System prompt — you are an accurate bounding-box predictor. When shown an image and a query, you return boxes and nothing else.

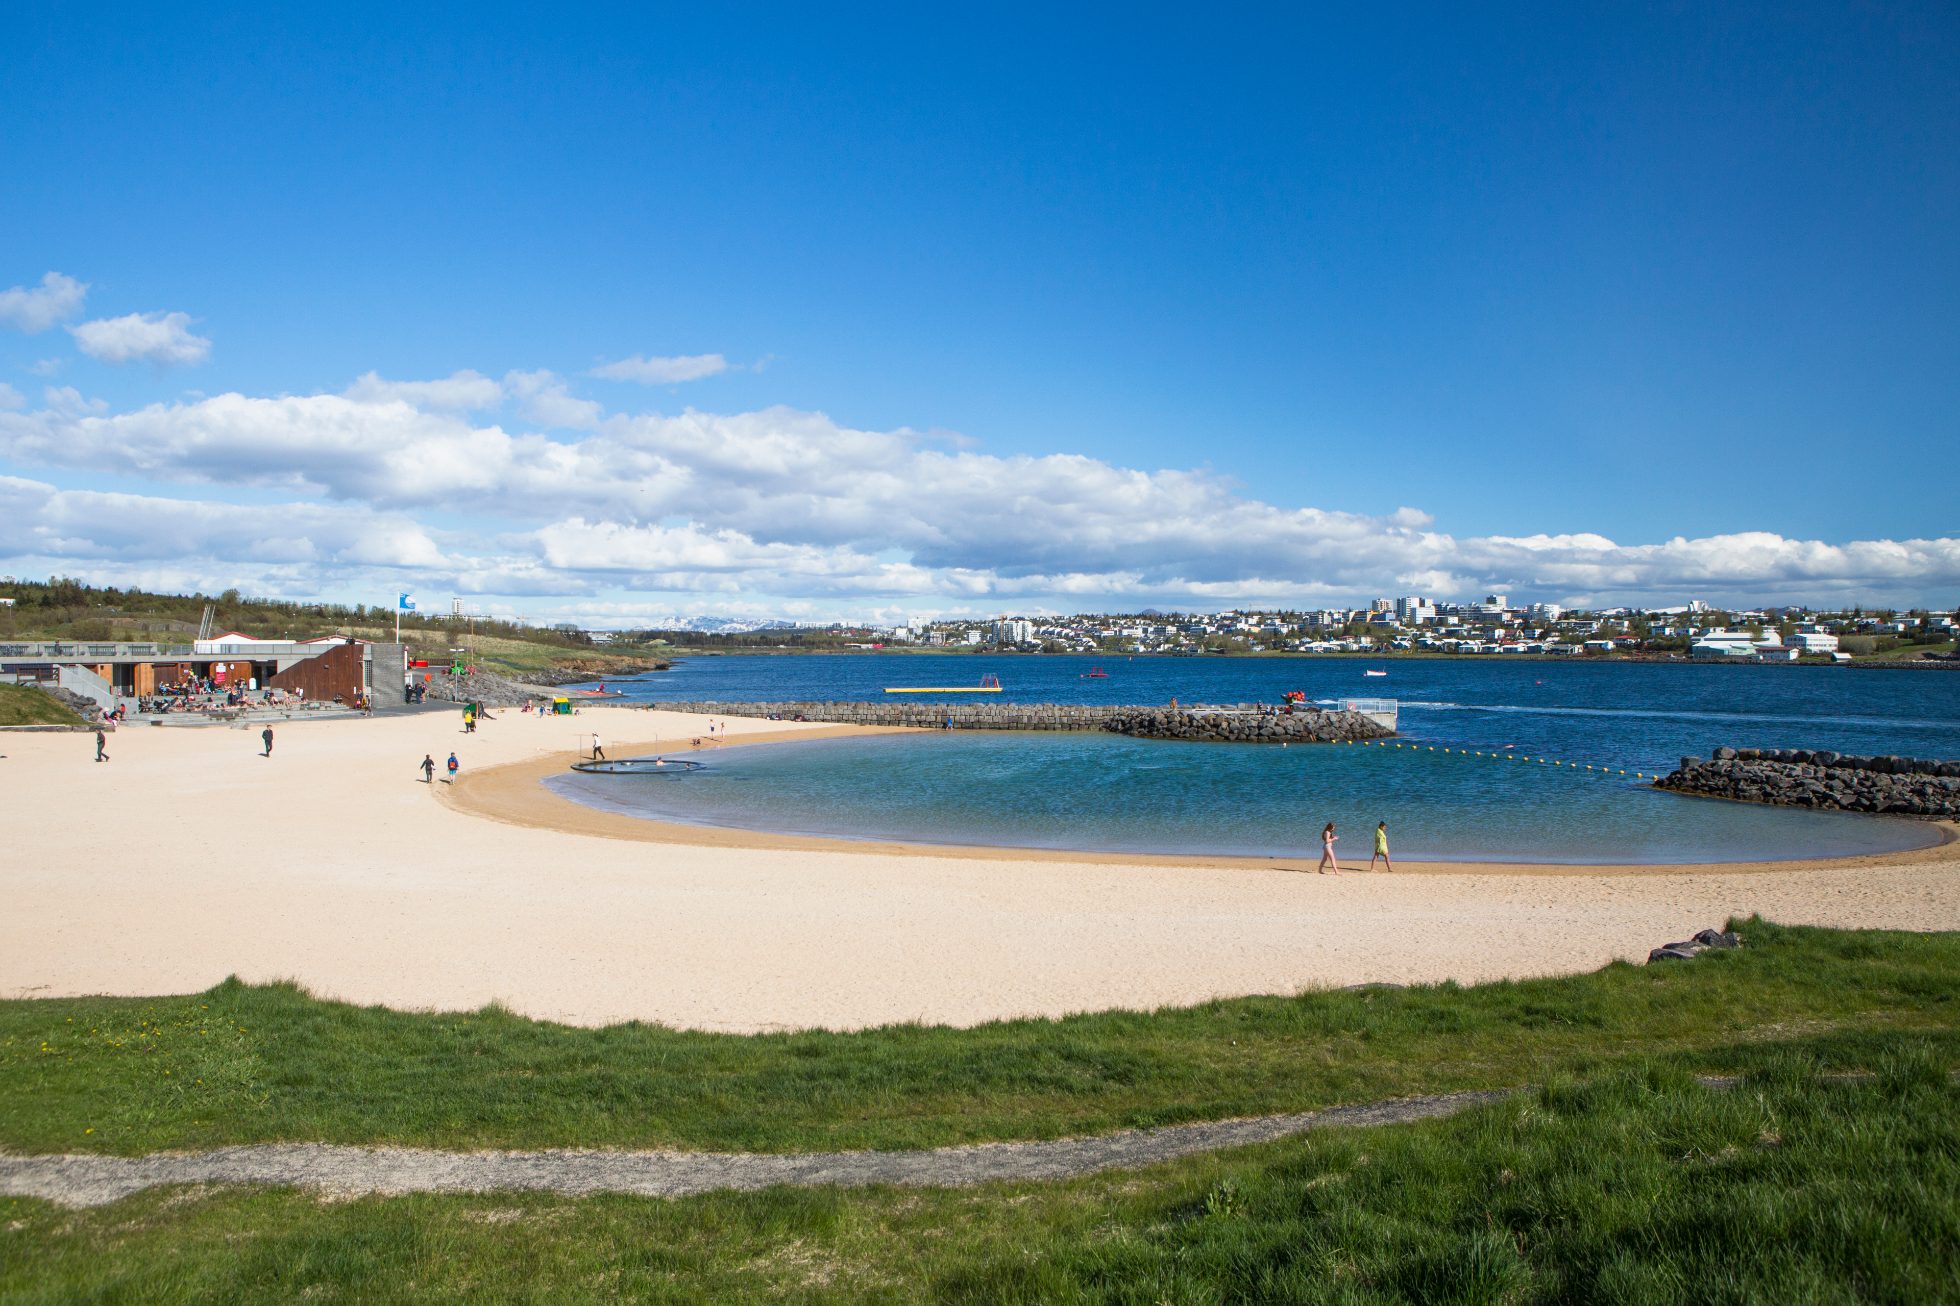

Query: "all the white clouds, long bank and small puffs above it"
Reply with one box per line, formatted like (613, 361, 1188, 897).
(0, 273, 1960, 622)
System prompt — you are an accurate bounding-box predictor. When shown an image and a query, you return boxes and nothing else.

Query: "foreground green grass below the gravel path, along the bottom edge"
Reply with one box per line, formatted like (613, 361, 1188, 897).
(0, 1035, 1960, 1304)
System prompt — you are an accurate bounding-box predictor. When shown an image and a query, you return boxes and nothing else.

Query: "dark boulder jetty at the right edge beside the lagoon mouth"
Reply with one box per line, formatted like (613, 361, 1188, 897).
(1656, 747, 1960, 820)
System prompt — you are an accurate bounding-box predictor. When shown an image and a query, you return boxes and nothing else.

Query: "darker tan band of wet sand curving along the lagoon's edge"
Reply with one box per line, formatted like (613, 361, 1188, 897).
(437, 718, 1960, 877)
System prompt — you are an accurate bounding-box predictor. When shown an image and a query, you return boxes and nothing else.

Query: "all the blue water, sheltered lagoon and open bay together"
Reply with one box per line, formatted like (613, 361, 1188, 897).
(549, 655, 1960, 863)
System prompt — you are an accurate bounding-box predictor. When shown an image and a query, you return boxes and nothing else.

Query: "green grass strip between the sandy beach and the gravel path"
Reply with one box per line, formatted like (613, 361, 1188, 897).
(11, 920, 1960, 1153)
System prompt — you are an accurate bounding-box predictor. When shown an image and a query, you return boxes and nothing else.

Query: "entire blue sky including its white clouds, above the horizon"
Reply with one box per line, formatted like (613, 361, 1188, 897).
(0, 4, 1960, 620)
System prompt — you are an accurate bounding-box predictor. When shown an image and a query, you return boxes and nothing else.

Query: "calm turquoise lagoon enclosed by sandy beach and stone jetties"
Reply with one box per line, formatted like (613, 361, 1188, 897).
(549, 731, 1936, 863)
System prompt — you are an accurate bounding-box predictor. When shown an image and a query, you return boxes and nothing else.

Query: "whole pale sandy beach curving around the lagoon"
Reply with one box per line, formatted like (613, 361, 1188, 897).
(11, 708, 1960, 1031)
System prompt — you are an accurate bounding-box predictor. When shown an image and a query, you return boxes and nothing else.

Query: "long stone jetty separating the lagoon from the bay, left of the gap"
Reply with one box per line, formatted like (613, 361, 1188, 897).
(647, 702, 1396, 743)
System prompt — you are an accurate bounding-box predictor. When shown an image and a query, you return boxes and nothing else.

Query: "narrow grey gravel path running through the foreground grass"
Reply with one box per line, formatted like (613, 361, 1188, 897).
(0, 1090, 1509, 1206)
